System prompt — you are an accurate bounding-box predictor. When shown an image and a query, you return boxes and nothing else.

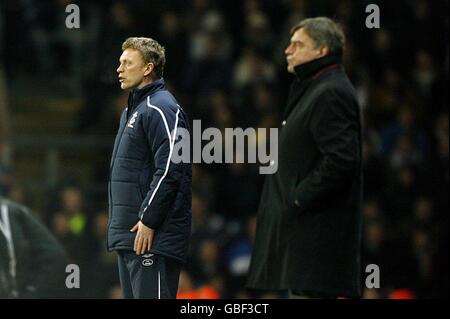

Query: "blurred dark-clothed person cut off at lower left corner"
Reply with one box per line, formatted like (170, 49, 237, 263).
(0, 197, 71, 299)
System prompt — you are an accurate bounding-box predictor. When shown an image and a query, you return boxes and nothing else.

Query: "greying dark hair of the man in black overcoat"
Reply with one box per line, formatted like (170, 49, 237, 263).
(291, 17, 345, 56)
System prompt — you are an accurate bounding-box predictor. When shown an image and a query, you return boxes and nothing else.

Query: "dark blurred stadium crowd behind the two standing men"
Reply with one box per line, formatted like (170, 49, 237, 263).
(0, 0, 449, 298)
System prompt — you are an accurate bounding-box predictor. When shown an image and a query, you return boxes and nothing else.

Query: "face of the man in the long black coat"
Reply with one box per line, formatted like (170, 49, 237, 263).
(284, 28, 328, 73)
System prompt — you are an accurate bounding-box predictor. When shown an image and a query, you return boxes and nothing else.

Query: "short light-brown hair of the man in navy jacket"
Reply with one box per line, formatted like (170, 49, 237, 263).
(122, 37, 166, 78)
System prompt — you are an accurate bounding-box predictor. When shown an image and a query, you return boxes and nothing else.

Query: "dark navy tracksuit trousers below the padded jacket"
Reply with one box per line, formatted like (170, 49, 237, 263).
(117, 251, 181, 299)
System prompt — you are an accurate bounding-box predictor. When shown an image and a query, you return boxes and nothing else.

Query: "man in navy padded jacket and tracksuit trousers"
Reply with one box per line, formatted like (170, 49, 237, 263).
(108, 38, 192, 299)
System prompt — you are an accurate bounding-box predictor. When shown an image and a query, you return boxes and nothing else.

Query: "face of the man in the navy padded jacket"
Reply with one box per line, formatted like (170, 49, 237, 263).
(117, 48, 153, 90)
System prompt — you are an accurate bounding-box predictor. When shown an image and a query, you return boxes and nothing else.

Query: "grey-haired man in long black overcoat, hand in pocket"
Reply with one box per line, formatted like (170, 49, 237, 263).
(247, 17, 362, 298)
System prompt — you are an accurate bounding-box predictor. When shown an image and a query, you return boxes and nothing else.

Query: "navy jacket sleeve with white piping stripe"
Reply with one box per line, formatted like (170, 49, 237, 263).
(139, 105, 184, 229)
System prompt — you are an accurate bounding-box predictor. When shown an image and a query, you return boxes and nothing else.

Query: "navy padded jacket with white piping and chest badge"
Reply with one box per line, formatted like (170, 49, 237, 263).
(108, 79, 192, 262)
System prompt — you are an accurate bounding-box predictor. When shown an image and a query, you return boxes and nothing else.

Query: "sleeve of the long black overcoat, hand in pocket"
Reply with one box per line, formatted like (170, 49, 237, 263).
(293, 90, 361, 212)
